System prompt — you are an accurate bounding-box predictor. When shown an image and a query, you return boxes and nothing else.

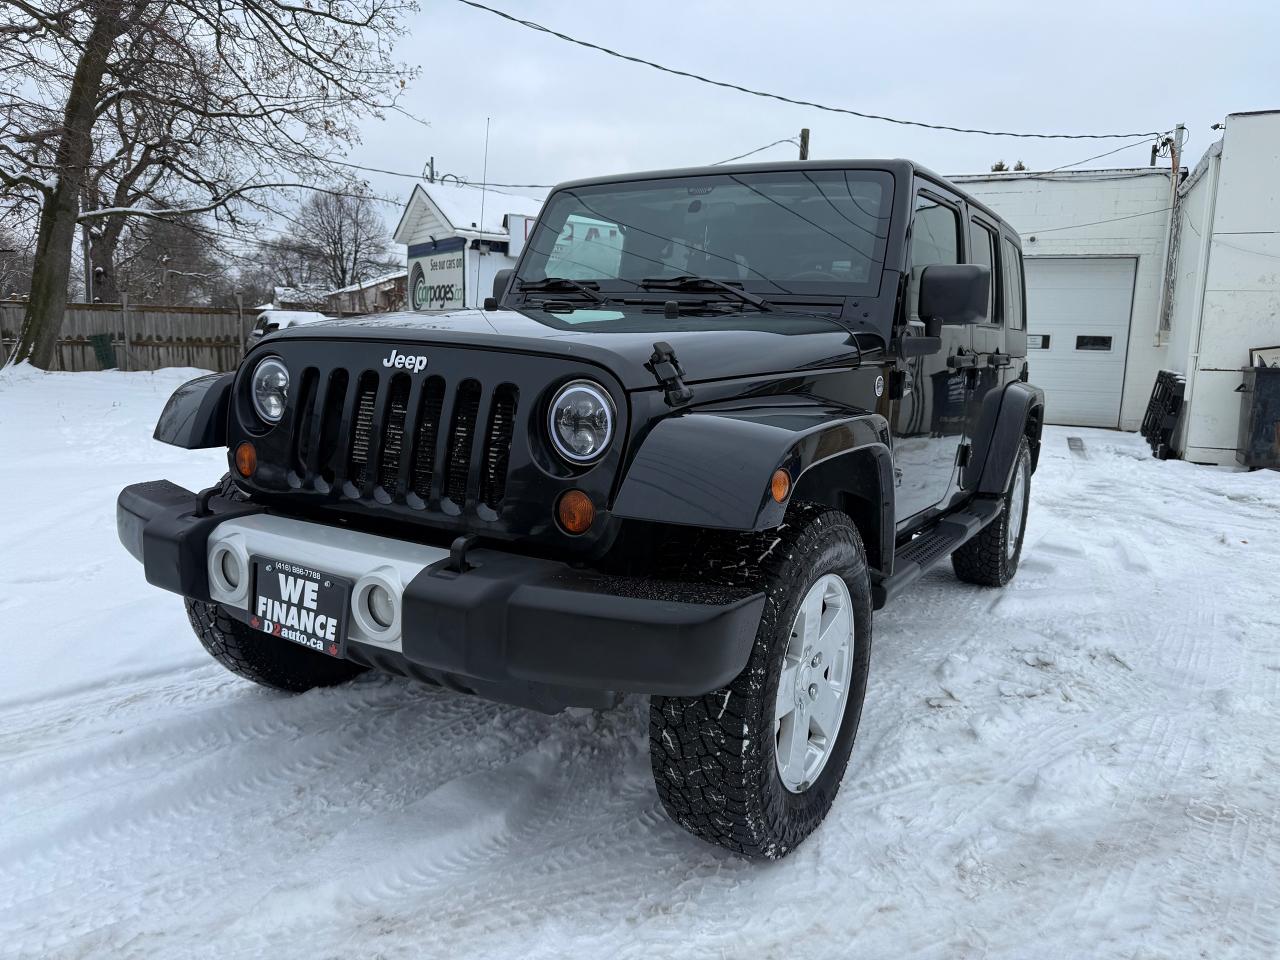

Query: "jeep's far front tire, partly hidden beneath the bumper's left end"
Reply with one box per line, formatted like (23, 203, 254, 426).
(186, 474, 365, 694)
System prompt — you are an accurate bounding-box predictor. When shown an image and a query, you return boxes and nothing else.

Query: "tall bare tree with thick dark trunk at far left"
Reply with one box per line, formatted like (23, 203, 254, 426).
(0, 0, 416, 366)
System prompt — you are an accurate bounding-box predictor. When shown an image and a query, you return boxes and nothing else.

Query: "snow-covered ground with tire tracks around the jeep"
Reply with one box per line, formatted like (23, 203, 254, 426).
(0, 371, 1280, 960)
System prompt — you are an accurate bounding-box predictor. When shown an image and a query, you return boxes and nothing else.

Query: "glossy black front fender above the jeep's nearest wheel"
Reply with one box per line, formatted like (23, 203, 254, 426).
(613, 401, 888, 530)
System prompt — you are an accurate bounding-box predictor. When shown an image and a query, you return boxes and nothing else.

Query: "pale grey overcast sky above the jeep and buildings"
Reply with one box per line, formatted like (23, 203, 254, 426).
(351, 0, 1280, 209)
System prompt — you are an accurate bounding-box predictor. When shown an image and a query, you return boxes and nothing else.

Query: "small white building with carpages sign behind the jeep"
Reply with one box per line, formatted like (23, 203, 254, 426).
(394, 182, 543, 311)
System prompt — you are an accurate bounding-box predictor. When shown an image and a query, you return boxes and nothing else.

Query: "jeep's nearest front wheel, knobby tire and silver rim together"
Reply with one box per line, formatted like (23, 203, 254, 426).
(649, 504, 872, 859)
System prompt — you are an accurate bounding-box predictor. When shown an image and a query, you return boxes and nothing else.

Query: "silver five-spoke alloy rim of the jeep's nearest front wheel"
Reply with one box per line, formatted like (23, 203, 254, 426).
(773, 573, 854, 794)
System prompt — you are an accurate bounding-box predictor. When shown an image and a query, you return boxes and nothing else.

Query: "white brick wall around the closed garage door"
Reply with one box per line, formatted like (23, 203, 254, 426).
(950, 168, 1170, 430)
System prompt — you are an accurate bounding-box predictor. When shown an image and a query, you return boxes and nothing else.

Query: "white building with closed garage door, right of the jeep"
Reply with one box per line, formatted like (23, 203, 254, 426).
(951, 110, 1280, 463)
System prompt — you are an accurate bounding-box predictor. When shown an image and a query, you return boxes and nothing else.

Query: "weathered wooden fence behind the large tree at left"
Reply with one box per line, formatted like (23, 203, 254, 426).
(0, 301, 253, 371)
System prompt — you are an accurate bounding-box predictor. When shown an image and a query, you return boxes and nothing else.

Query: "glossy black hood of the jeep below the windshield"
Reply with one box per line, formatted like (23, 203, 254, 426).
(270, 305, 858, 390)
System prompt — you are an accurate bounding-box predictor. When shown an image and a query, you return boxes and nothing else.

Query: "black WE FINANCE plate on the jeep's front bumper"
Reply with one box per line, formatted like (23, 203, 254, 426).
(248, 557, 351, 657)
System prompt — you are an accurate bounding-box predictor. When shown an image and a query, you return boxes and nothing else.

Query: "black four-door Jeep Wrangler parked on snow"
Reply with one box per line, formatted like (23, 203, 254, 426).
(116, 160, 1044, 858)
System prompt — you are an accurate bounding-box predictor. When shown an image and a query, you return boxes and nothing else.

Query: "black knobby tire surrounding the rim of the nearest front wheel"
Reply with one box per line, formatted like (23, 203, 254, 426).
(649, 504, 872, 859)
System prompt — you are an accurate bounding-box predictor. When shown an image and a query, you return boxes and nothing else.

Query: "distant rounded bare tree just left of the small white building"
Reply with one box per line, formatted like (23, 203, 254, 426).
(292, 183, 399, 289)
